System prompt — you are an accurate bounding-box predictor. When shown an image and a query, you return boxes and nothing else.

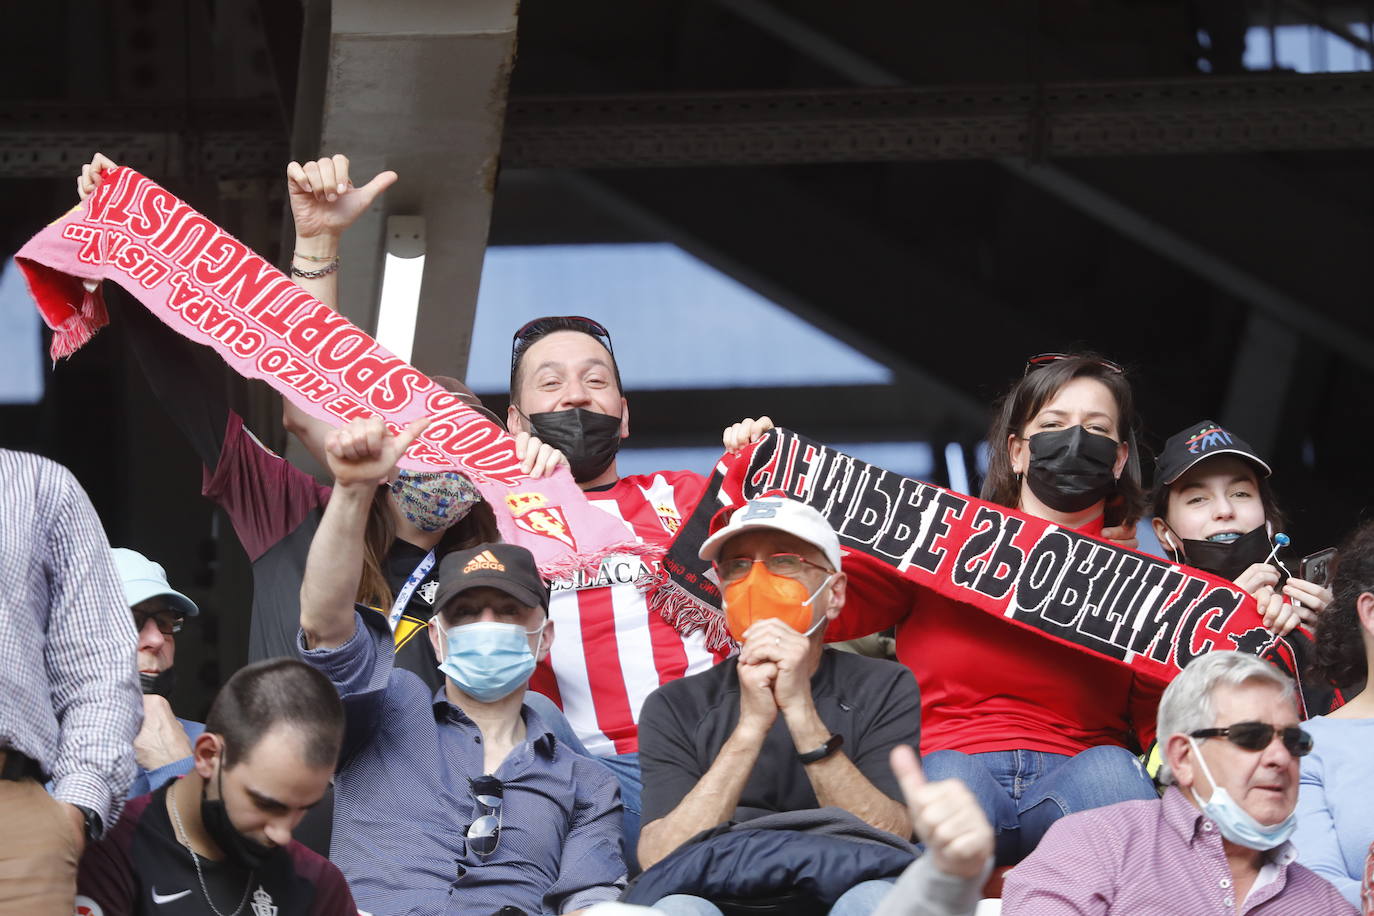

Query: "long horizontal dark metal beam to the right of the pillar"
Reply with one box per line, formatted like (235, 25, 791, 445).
(503, 74, 1374, 169)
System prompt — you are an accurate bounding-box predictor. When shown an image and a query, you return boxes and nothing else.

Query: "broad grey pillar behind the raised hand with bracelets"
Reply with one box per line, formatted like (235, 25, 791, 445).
(297, 0, 518, 378)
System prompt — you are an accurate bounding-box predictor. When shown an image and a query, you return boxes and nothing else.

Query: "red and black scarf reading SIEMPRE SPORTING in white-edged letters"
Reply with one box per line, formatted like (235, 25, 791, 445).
(649, 430, 1293, 694)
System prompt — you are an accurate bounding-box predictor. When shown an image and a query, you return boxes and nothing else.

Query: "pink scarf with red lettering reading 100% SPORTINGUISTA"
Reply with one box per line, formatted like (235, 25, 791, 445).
(15, 168, 642, 577)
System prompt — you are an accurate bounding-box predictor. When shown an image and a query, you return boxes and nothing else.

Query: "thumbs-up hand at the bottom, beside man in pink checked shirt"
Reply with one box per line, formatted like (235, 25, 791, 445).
(890, 744, 993, 878)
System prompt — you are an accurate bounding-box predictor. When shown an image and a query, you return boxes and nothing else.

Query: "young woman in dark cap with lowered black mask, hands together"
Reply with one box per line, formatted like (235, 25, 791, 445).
(1150, 420, 1334, 714)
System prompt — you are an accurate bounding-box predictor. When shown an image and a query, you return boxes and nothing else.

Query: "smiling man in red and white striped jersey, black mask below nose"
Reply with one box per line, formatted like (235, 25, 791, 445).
(507, 317, 772, 856)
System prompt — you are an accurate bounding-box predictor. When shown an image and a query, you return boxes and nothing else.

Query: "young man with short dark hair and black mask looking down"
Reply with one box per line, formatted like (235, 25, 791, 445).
(76, 659, 357, 916)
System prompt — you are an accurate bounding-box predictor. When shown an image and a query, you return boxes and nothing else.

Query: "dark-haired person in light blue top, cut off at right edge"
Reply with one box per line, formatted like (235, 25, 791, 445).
(1293, 522, 1374, 906)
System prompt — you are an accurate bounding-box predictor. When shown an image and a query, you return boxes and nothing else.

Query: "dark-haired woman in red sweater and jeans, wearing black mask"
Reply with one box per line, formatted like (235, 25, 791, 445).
(827, 353, 1158, 865)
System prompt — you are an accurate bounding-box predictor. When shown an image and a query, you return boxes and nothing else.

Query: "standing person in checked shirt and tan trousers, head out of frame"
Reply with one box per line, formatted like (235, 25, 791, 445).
(0, 449, 143, 916)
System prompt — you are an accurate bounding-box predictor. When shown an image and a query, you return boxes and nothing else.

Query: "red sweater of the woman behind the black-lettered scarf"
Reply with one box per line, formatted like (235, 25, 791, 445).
(826, 518, 1160, 754)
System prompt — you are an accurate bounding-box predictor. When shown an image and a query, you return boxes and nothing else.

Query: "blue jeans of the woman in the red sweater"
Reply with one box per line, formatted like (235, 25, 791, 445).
(921, 744, 1160, 865)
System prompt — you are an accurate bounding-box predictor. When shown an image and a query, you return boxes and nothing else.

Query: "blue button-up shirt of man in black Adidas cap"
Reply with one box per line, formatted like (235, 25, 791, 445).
(300, 614, 625, 916)
